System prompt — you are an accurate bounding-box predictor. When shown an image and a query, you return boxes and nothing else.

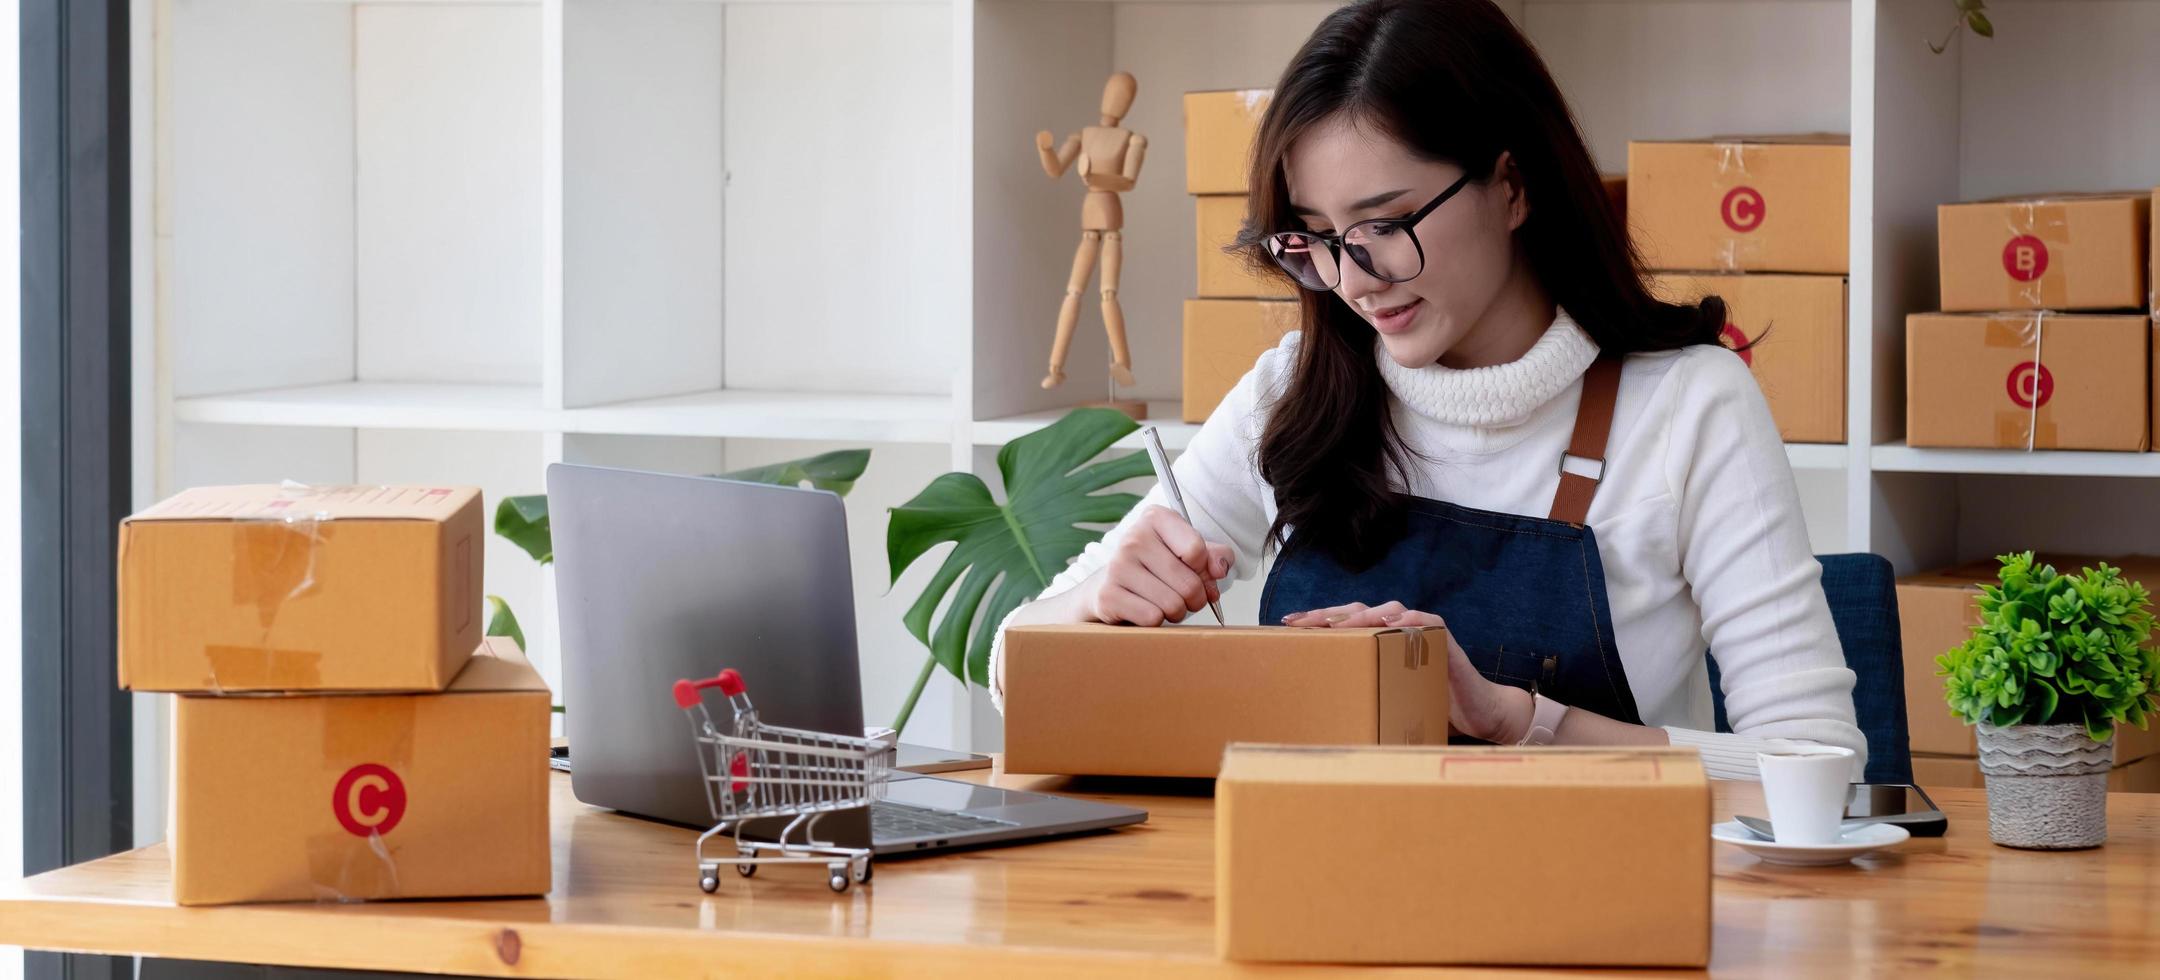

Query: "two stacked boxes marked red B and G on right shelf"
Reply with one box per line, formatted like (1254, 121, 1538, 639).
(1905, 192, 2154, 451)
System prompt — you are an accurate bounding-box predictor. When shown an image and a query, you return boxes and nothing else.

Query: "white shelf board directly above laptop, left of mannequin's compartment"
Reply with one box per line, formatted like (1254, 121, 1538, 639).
(559, 391, 953, 443)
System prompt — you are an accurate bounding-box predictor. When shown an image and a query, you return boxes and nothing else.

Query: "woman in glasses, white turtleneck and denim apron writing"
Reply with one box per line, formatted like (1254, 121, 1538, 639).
(991, 0, 1866, 777)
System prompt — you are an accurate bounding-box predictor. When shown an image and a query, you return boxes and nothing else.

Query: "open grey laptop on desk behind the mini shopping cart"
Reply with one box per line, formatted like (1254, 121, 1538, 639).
(546, 464, 1147, 855)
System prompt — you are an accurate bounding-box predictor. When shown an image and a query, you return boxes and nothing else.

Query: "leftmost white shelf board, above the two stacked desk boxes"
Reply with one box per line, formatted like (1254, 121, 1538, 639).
(173, 382, 549, 432)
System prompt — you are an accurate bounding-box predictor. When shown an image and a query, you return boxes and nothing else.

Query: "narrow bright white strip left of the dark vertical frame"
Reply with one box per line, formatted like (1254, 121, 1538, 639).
(0, 0, 22, 980)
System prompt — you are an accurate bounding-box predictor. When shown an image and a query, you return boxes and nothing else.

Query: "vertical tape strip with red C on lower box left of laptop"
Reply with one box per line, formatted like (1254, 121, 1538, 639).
(307, 695, 419, 902)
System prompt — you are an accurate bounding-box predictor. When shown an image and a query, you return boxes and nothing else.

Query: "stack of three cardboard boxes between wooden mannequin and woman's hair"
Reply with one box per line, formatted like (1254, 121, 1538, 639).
(1184, 89, 1298, 421)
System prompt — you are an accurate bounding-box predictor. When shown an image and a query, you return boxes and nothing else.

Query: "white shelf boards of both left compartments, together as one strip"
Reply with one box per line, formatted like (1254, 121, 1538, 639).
(173, 382, 953, 443)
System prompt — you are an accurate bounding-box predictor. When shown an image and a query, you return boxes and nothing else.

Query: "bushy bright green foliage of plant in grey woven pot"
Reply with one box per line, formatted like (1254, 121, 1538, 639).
(1935, 550, 2160, 740)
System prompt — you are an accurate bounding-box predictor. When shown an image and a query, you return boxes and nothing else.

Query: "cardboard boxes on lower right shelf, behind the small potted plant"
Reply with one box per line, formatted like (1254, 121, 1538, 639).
(1896, 555, 2160, 792)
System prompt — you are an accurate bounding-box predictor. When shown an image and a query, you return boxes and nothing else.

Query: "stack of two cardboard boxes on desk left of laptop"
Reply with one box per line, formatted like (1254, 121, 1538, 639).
(119, 486, 549, 904)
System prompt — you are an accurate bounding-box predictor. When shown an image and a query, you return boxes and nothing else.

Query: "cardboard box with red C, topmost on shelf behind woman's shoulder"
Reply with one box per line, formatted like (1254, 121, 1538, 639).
(1626, 134, 1851, 274)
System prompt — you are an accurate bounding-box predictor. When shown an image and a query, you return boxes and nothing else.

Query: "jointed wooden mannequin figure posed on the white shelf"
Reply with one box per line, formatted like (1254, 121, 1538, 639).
(1035, 71, 1147, 389)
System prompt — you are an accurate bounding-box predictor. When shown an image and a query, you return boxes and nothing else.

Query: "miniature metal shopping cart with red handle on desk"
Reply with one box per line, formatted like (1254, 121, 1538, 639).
(674, 667, 894, 891)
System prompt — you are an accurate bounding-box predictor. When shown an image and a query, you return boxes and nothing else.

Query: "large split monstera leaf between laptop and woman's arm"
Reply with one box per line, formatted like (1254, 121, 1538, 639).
(886, 408, 1151, 699)
